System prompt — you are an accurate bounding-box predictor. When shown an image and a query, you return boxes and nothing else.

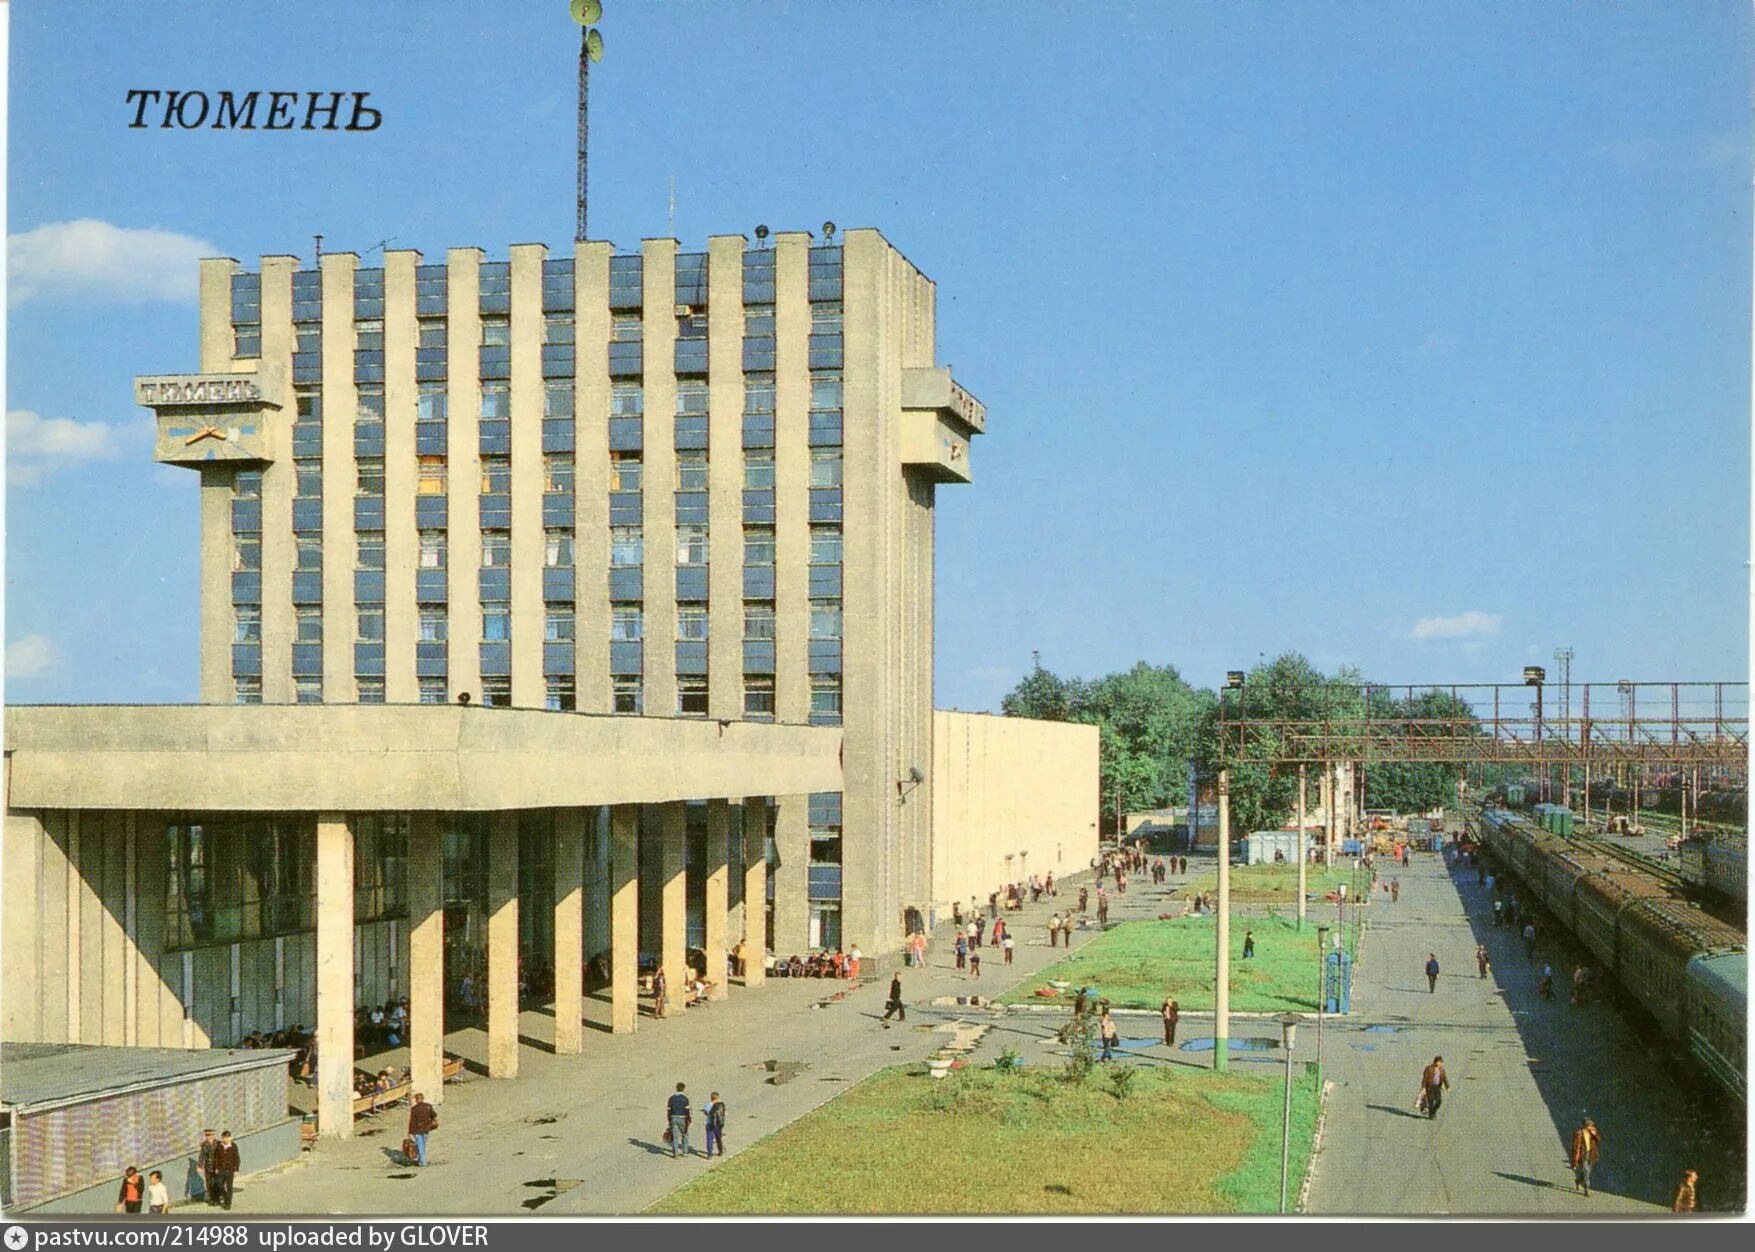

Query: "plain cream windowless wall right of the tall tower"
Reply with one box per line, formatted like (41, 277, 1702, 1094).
(932, 709, 1097, 915)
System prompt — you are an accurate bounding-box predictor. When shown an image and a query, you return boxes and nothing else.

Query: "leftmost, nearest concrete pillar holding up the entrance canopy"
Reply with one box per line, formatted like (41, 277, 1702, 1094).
(318, 813, 355, 1140)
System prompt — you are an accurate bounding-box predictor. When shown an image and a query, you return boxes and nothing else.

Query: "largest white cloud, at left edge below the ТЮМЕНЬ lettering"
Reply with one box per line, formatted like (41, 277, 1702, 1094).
(7, 218, 219, 306)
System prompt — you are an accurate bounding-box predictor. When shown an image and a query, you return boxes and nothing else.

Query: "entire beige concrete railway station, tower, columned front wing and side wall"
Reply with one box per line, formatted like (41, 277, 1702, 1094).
(0, 230, 1097, 1134)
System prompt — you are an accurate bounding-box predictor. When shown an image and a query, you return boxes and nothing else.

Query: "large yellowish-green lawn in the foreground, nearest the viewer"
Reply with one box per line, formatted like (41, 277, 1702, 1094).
(649, 1066, 1318, 1213)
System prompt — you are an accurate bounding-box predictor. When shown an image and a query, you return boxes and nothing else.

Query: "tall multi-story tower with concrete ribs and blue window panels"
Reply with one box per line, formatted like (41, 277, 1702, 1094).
(140, 230, 985, 950)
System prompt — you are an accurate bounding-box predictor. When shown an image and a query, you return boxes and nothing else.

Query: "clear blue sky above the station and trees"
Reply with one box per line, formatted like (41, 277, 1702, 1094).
(5, 0, 1751, 708)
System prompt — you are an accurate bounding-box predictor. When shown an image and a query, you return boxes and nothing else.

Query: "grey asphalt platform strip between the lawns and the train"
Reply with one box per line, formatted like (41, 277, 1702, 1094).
(1300, 853, 1743, 1217)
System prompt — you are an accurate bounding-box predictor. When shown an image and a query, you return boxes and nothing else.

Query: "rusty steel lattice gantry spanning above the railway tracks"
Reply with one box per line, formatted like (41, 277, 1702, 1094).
(1218, 671, 1748, 771)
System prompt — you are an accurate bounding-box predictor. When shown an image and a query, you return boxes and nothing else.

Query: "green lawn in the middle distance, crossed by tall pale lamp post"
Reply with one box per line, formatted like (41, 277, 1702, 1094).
(1000, 915, 1357, 1013)
